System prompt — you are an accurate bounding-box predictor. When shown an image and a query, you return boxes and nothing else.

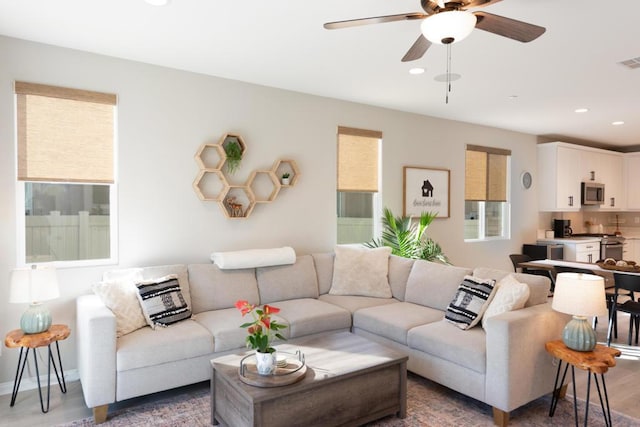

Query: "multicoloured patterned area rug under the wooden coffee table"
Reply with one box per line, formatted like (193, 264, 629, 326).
(58, 374, 640, 427)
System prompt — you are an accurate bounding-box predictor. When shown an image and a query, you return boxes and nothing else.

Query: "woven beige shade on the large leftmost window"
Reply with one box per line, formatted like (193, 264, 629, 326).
(15, 82, 116, 183)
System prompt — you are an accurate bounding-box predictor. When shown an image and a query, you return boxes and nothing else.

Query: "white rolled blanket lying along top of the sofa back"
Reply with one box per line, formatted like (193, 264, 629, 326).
(211, 246, 296, 270)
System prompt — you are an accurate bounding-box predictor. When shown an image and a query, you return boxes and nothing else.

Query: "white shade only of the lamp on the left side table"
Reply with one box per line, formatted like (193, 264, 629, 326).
(9, 266, 60, 304)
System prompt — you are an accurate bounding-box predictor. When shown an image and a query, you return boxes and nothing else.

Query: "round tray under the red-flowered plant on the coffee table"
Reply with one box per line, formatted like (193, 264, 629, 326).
(238, 350, 307, 387)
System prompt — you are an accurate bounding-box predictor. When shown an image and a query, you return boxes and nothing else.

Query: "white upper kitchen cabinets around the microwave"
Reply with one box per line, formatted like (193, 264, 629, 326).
(538, 142, 624, 212)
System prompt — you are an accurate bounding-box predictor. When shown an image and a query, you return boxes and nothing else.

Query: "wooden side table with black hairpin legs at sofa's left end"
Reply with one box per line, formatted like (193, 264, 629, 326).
(4, 325, 71, 413)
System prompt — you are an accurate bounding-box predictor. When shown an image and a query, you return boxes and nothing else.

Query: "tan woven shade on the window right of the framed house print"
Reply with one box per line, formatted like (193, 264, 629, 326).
(464, 145, 511, 202)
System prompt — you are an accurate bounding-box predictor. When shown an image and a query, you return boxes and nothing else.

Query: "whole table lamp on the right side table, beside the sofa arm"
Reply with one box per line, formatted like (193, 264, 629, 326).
(551, 273, 607, 351)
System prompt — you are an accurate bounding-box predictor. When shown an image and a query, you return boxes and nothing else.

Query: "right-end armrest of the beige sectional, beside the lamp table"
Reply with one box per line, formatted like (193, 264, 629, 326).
(485, 303, 570, 412)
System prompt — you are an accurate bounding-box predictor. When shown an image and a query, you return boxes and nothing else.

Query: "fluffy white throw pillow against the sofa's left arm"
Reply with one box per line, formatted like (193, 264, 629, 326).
(92, 273, 147, 337)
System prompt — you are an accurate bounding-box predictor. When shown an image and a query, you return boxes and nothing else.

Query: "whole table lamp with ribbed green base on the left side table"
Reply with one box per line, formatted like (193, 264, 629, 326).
(9, 265, 60, 334)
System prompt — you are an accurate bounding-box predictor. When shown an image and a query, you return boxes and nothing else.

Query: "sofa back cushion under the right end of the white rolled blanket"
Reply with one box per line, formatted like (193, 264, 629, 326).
(256, 255, 318, 304)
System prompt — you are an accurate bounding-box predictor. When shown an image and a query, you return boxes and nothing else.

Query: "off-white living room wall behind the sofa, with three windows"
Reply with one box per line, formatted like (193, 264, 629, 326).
(0, 37, 538, 384)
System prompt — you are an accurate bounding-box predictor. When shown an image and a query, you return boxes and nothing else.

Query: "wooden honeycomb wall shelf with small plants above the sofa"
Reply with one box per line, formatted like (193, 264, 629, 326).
(193, 133, 300, 219)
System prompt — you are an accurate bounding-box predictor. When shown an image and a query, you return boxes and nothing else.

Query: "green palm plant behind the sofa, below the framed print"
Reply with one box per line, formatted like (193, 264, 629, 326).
(364, 208, 450, 264)
